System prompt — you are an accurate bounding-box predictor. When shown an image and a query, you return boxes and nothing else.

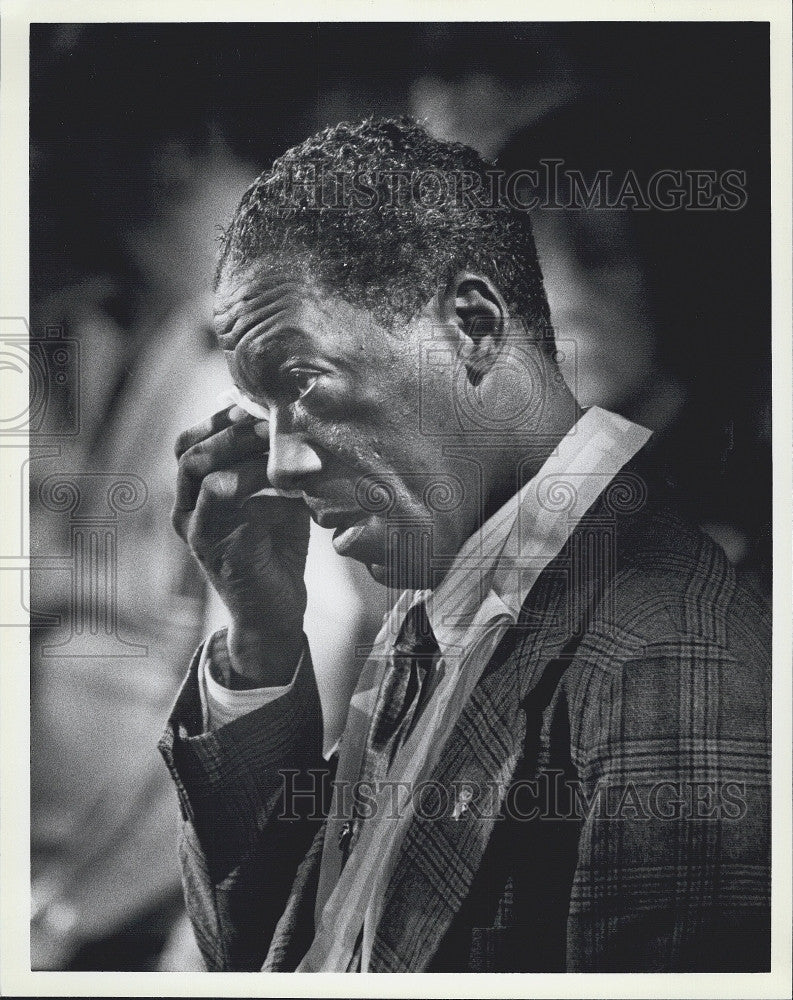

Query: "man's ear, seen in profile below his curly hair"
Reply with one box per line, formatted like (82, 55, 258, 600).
(439, 271, 508, 385)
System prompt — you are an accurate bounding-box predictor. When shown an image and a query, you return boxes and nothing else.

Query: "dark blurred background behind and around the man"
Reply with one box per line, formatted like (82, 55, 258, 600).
(30, 23, 771, 969)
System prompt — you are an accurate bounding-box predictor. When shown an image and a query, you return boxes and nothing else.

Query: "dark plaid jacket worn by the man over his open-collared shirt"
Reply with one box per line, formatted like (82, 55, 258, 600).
(160, 463, 770, 972)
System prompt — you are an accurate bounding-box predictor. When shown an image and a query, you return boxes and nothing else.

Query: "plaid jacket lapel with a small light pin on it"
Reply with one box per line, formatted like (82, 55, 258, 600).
(369, 567, 570, 972)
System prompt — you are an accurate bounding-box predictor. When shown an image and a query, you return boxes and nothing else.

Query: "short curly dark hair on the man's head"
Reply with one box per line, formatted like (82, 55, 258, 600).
(216, 117, 553, 343)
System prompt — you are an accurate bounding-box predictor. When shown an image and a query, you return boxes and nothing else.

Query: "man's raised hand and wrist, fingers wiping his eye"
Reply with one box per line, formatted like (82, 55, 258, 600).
(172, 407, 309, 686)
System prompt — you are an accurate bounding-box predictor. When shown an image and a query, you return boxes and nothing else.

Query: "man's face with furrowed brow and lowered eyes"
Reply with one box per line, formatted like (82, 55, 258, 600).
(215, 268, 481, 587)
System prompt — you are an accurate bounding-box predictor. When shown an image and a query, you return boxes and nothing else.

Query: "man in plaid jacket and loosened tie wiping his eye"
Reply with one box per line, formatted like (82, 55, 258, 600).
(161, 119, 769, 971)
